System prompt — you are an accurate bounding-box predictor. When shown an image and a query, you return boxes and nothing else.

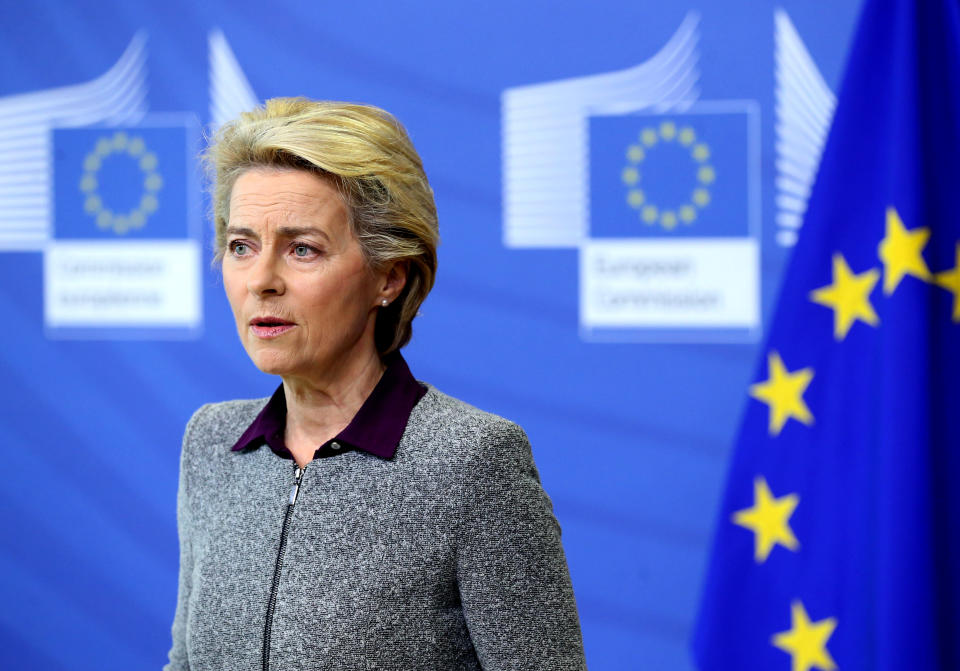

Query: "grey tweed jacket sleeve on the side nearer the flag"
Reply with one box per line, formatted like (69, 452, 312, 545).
(457, 420, 586, 671)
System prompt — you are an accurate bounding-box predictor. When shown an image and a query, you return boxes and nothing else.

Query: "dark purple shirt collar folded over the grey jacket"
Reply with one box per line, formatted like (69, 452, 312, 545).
(231, 352, 427, 459)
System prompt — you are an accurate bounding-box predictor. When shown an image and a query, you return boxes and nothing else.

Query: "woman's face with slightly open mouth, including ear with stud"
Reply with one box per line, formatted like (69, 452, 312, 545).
(223, 169, 388, 380)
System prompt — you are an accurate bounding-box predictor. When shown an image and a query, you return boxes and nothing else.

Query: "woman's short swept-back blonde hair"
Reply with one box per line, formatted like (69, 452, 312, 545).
(204, 98, 440, 355)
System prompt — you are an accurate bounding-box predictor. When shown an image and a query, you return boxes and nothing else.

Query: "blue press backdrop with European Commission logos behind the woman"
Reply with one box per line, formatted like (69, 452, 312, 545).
(0, 0, 860, 670)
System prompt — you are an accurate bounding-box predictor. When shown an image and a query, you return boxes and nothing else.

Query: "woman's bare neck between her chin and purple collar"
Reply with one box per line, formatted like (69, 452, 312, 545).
(283, 352, 385, 466)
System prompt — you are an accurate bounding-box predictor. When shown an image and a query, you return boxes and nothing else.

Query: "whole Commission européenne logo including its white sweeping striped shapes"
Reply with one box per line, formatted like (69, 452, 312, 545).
(0, 29, 257, 339)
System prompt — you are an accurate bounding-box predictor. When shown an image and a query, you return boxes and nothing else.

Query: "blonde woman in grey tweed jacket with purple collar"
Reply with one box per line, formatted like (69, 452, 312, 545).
(166, 99, 585, 671)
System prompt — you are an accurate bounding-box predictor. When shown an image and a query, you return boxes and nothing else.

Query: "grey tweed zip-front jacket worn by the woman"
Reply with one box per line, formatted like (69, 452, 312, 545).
(164, 387, 586, 671)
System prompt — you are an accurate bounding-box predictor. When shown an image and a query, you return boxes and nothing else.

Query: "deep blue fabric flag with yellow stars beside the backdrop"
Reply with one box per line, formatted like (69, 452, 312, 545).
(694, 0, 960, 671)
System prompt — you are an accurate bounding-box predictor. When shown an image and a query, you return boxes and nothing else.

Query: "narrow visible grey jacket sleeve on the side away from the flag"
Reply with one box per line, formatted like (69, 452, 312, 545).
(163, 406, 208, 671)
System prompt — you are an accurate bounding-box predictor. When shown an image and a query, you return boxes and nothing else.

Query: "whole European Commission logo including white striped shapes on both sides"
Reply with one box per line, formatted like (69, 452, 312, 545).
(503, 10, 832, 342)
